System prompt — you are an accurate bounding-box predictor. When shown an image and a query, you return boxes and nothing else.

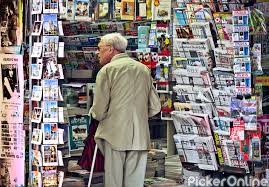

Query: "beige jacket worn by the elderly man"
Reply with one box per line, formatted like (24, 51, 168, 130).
(90, 53, 161, 151)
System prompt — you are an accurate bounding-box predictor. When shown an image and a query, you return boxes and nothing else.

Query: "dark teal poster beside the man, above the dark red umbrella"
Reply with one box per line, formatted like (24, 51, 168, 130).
(69, 115, 90, 151)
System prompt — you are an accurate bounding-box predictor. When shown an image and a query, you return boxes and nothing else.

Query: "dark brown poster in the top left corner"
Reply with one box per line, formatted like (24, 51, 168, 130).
(0, 0, 23, 54)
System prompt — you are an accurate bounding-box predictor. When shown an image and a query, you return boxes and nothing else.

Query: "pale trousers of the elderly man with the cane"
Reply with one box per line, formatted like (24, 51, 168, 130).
(98, 140, 148, 187)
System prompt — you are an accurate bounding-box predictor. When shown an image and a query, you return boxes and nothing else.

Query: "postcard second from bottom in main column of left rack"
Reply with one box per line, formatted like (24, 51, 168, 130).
(41, 145, 58, 166)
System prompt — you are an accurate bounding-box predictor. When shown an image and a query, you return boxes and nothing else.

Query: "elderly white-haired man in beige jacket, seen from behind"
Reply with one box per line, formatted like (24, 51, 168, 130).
(90, 33, 161, 187)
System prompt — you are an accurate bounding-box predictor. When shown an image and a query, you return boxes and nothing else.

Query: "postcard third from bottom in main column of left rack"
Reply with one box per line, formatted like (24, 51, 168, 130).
(42, 123, 58, 144)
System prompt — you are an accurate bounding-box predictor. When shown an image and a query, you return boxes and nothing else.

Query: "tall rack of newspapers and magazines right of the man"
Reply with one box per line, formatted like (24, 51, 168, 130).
(172, 0, 266, 181)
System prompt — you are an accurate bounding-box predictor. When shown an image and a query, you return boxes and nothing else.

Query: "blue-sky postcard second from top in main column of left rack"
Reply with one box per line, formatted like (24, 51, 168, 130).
(43, 14, 59, 35)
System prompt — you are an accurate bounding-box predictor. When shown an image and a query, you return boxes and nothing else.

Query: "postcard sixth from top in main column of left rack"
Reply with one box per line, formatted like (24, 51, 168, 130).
(42, 101, 58, 122)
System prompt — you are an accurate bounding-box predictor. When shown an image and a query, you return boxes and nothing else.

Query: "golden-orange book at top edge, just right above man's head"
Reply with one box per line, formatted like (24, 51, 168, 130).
(121, 0, 135, 20)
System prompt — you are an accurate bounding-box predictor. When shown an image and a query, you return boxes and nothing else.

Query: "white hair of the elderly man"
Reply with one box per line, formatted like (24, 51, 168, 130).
(101, 33, 128, 53)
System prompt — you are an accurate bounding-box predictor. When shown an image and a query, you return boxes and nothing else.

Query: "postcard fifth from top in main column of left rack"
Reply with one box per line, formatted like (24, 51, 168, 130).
(42, 79, 59, 101)
